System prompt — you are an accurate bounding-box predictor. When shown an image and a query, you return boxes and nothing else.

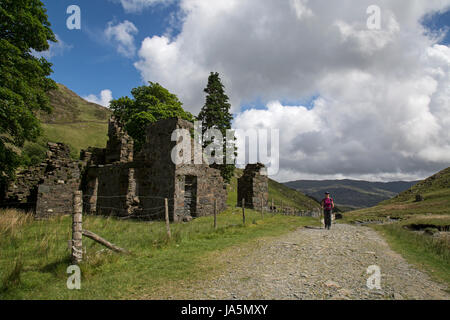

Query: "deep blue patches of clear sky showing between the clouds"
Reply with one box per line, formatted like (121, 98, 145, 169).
(43, 0, 450, 110)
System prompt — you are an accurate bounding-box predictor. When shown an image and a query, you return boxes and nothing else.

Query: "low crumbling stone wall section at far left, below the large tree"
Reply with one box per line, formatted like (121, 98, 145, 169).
(2, 143, 81, 218)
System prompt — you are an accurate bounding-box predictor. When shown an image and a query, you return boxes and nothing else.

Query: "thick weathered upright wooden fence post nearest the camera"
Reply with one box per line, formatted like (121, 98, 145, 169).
(71, 191, 83, 264)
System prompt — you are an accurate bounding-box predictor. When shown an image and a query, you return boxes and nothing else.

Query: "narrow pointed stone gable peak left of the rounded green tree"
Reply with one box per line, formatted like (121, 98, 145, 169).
(104, 116, 134, 164)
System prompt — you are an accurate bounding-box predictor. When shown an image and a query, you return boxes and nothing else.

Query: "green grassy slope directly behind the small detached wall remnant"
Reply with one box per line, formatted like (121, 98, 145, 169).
(228, 169, 320, 210)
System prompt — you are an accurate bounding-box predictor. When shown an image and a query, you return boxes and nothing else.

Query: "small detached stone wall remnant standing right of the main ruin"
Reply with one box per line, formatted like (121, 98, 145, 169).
(237, 163, 269, 210)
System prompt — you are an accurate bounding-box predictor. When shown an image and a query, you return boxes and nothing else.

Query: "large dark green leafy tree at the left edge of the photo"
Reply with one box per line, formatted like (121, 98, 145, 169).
(0, 0, 56, 183)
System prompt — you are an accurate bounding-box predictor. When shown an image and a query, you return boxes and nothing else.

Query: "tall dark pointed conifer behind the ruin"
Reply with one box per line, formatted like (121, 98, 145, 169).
(198, 72, 237, 183)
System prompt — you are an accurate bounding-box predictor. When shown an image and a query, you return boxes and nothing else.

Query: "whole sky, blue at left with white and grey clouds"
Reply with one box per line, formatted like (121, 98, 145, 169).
(37, 0, 450, 181)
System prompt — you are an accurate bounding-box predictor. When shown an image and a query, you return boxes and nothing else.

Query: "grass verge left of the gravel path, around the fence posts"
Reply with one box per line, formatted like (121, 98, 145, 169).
(0, 208, 317, 299)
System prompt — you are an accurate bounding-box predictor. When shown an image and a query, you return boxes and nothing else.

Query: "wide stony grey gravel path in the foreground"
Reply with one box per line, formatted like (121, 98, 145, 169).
(171, 224, 450, 300)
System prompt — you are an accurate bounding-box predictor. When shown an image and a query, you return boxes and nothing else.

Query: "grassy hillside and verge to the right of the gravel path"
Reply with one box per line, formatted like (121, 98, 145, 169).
(344, 168, 450, 286)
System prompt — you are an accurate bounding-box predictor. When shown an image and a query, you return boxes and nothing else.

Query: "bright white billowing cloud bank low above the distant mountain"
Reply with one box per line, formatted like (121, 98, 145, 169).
(234, 45, 450, 181)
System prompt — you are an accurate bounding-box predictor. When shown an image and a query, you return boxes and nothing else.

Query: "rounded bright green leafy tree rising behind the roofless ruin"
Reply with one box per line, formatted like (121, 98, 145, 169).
(110, 82, 194, 151)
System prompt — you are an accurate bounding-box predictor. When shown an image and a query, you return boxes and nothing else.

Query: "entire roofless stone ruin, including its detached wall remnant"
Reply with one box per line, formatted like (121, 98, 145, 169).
(0, 117, 268, 222)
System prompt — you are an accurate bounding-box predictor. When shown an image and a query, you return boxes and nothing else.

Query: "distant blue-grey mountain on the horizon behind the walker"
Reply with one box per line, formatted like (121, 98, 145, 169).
(285, 180, 418, 210)
